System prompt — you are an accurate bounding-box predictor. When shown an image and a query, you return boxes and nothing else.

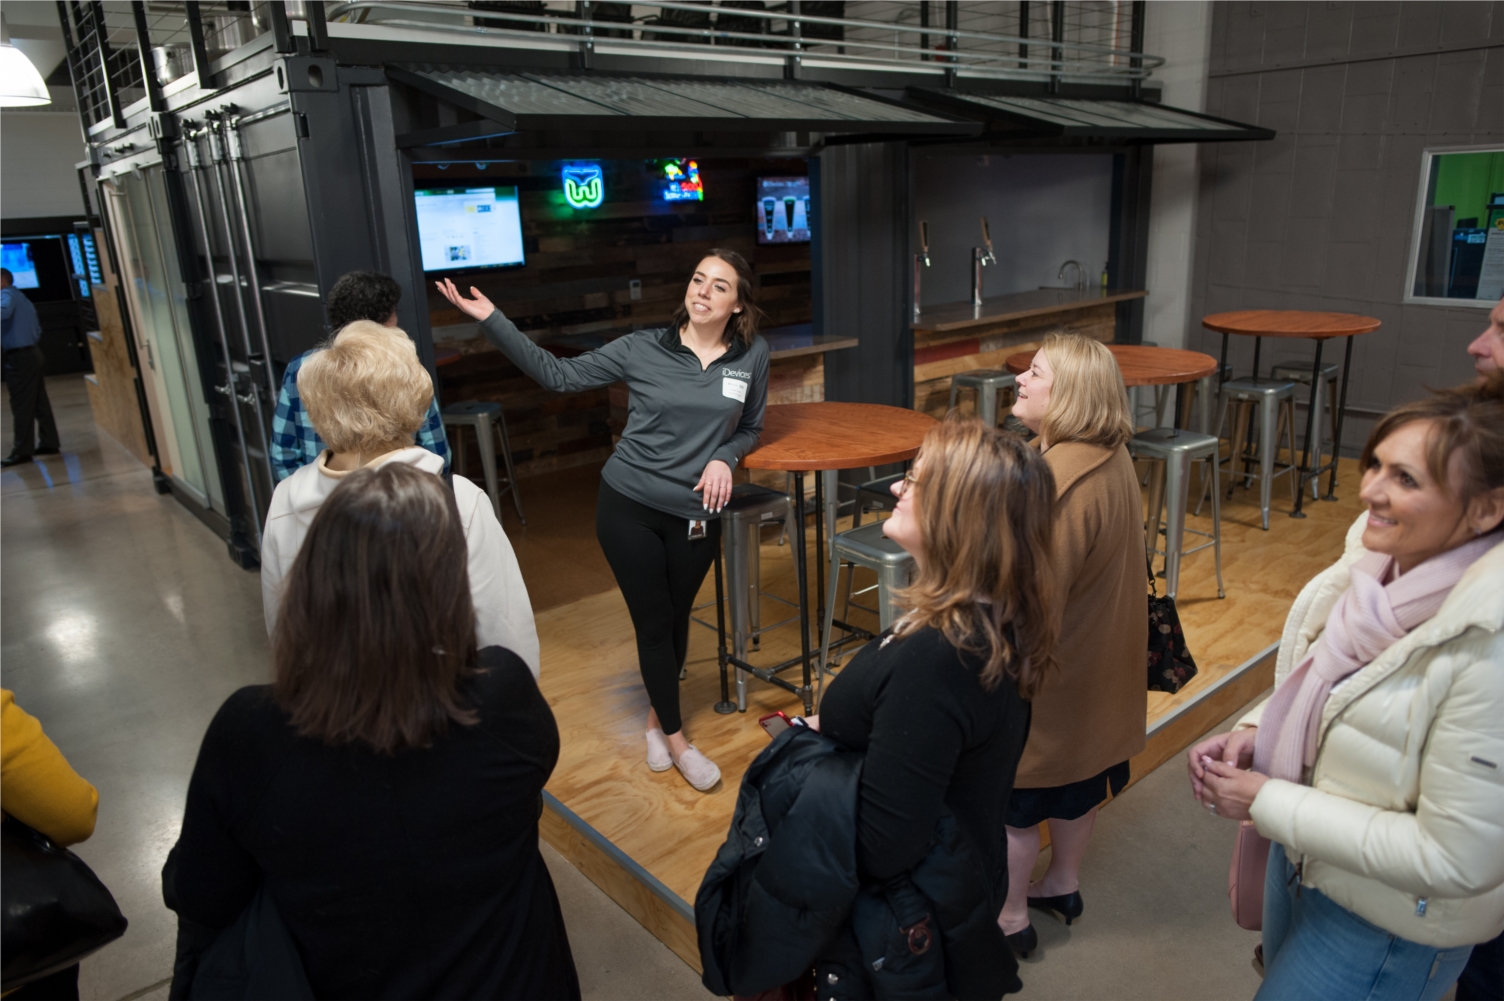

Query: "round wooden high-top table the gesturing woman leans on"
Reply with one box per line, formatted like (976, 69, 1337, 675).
(730, 403, 937, 712)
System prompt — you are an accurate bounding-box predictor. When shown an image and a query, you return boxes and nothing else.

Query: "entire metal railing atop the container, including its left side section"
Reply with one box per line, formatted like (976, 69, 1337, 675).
(57, 0, 1164, 134)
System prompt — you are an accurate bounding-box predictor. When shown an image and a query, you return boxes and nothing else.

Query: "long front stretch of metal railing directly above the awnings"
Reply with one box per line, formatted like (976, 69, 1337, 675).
(326, 0, 1164, 84)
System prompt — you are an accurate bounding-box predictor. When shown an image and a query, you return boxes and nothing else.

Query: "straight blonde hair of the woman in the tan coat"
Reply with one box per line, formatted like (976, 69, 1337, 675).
(1039, 334, 1137, 448)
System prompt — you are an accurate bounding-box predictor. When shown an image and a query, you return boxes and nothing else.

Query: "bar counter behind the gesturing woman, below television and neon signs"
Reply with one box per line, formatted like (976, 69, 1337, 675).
(433, 323, 859, 478)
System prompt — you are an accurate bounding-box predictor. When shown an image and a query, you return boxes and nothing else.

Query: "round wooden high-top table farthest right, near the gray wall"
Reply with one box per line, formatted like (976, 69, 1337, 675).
(1202, 310, 1382, 519)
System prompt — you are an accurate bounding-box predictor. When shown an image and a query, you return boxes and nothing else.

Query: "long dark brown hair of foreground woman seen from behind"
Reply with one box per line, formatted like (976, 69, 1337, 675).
(272, 463, 475, 755)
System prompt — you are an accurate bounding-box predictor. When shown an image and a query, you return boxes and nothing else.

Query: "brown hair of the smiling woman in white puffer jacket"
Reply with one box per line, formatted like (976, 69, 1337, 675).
(1360, 373, 1504, 508)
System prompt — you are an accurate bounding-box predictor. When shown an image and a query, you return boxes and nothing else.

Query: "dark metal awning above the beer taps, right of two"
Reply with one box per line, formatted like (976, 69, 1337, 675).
(908, 87, 1274, 143)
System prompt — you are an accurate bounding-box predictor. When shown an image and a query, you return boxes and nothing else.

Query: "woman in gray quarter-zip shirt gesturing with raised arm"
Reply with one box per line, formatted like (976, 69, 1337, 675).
(438, 249, 769, 792)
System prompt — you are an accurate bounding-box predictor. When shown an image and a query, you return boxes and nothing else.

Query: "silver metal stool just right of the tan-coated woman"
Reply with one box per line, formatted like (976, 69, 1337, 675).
(1128, 427, 1227, 598)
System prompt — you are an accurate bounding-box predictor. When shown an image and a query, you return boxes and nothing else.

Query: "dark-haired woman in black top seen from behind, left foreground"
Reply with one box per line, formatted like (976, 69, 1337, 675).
(164, 463, 579, 998)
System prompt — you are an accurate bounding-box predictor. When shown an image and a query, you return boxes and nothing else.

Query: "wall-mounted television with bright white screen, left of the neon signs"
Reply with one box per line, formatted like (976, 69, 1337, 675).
(414, 186, 526, 271)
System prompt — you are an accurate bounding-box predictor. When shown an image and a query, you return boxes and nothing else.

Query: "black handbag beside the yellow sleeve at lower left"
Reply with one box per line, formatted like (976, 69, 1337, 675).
(0, 816, 126, 990)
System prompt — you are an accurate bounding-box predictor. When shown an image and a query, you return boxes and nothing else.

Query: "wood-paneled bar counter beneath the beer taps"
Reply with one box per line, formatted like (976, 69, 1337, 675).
(911, 289, 1149, 418)
